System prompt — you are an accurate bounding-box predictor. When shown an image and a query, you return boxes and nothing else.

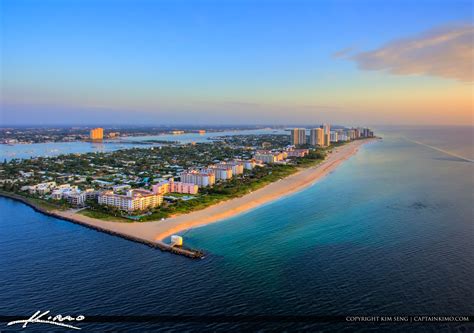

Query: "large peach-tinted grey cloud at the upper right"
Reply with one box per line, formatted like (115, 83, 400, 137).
(346, 25, 474, 82)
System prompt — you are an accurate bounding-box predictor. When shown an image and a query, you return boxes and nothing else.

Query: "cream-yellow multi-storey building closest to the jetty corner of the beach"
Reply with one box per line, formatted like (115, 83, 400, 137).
(97, 189, 163, 212)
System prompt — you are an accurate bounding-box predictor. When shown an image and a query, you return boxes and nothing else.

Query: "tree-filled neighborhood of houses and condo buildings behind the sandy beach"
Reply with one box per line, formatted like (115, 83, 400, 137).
(0, 125, 370, 220)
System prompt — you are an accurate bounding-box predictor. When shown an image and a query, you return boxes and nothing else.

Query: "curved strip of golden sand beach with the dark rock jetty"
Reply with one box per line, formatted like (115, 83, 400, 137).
(0, 139, 373, 258)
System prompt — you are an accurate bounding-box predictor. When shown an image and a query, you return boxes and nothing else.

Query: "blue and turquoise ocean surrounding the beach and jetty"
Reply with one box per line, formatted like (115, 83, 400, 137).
(0, 128, 474, 332)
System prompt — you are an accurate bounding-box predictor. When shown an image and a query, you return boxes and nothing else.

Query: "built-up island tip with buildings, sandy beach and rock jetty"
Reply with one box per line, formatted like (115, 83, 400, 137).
(0, 129, 374, 257)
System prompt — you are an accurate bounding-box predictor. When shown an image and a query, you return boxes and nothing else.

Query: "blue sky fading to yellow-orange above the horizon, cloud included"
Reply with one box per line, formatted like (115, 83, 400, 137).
(0, 0, 474, 126)
